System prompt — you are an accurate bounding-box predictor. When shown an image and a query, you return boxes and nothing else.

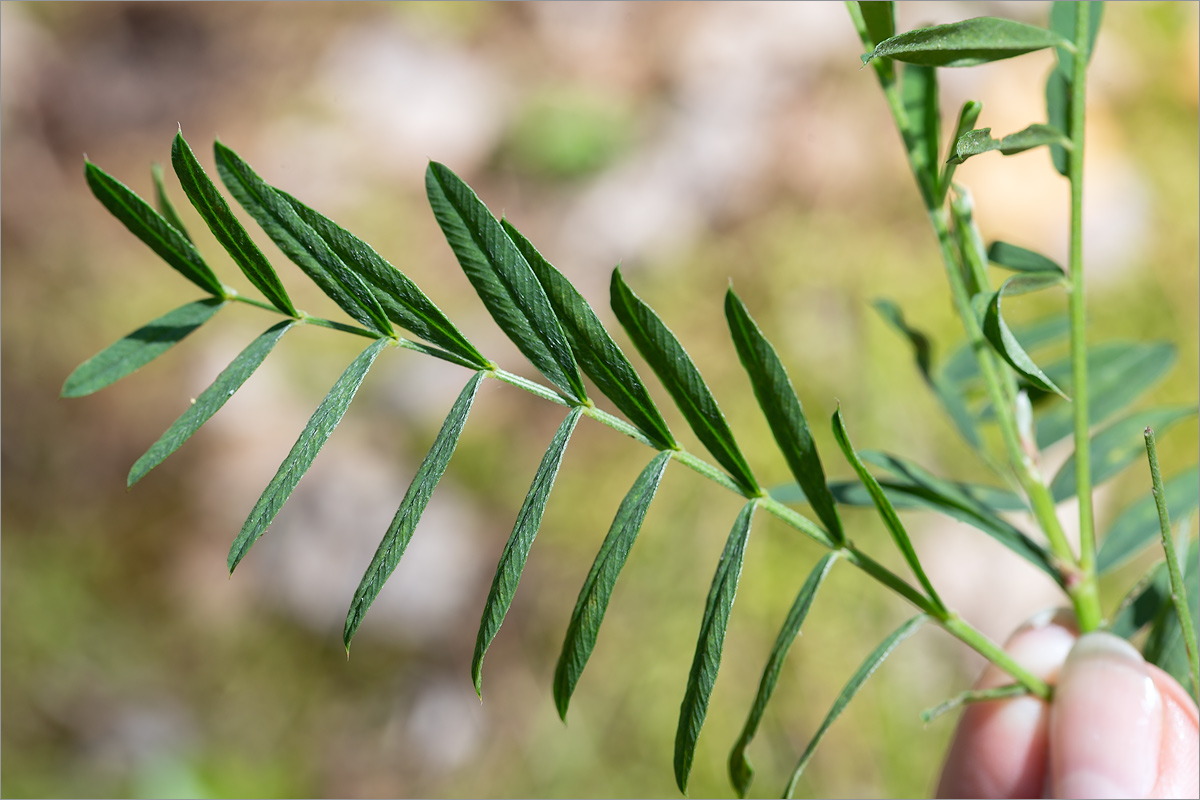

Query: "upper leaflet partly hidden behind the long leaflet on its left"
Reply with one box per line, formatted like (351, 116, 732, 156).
(275, 188, 494, 369)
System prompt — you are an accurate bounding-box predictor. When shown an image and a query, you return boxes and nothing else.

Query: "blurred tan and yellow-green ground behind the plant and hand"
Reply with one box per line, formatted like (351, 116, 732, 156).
(0, 2, 1200, 798)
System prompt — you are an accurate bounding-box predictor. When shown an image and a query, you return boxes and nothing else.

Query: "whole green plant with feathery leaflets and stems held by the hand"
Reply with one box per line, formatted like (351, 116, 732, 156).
(62, 2, 1200, 795)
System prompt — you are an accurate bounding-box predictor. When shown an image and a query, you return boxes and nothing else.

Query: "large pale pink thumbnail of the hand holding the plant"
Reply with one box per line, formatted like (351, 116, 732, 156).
(1050, 633, 1163, 798)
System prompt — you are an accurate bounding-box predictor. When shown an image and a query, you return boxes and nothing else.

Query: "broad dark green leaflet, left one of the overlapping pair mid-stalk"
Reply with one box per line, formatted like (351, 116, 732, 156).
(425, 161, 587, 403)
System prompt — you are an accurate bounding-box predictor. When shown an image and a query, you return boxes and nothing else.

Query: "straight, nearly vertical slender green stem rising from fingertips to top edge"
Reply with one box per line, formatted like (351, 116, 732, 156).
(1067, 2, 1102, 633)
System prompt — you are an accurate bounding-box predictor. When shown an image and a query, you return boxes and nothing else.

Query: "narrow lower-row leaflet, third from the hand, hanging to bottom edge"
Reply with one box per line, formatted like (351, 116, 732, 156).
(674, 500, 758, 794)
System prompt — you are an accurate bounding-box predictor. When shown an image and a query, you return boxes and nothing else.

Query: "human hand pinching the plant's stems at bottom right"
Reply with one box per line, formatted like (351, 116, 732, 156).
(937, 612, 1200, 798)
